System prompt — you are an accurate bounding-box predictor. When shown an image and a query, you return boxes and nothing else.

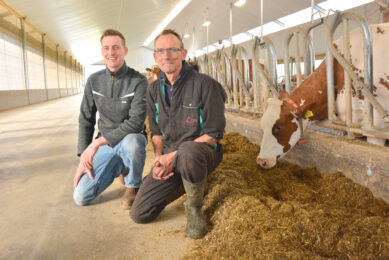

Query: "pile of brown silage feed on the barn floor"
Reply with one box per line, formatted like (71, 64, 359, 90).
(186, 133, 389, 259)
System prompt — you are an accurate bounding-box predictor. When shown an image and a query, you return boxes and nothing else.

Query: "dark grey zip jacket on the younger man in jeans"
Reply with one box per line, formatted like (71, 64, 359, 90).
(77, 63, 148, 155)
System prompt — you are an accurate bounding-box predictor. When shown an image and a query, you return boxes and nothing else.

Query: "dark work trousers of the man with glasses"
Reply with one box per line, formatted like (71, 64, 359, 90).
(130, 142, 223, 223)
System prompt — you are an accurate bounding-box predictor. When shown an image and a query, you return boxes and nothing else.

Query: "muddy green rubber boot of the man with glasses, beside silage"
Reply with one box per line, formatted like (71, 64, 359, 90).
(182, 178, 208, 238)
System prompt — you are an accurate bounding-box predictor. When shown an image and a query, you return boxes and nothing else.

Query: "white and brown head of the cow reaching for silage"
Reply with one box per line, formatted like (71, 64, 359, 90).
(257, 93, 304, 169)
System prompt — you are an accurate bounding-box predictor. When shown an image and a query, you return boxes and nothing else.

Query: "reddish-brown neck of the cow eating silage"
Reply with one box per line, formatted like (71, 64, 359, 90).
(284, 60, 344, 120)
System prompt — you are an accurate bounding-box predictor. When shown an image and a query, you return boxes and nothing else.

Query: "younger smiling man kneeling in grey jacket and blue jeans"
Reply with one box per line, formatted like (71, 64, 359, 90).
(73, 29, 148, 209)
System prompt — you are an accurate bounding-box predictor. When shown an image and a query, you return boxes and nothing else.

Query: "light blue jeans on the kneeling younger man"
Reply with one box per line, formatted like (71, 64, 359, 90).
(73, 134, 147, 206)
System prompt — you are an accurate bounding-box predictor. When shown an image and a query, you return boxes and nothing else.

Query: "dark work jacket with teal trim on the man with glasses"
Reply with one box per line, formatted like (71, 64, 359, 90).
(147, 68, 226, 153)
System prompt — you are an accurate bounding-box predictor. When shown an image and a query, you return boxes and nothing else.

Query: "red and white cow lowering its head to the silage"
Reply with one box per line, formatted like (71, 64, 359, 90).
(257, 23, 389, 169)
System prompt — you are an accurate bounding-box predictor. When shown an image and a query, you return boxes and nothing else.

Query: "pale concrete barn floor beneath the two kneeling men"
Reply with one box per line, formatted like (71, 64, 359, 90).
(0, 95, 193, 259)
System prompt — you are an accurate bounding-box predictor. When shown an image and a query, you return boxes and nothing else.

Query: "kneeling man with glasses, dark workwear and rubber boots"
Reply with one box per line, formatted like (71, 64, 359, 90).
(130, 30, 226, 238)
